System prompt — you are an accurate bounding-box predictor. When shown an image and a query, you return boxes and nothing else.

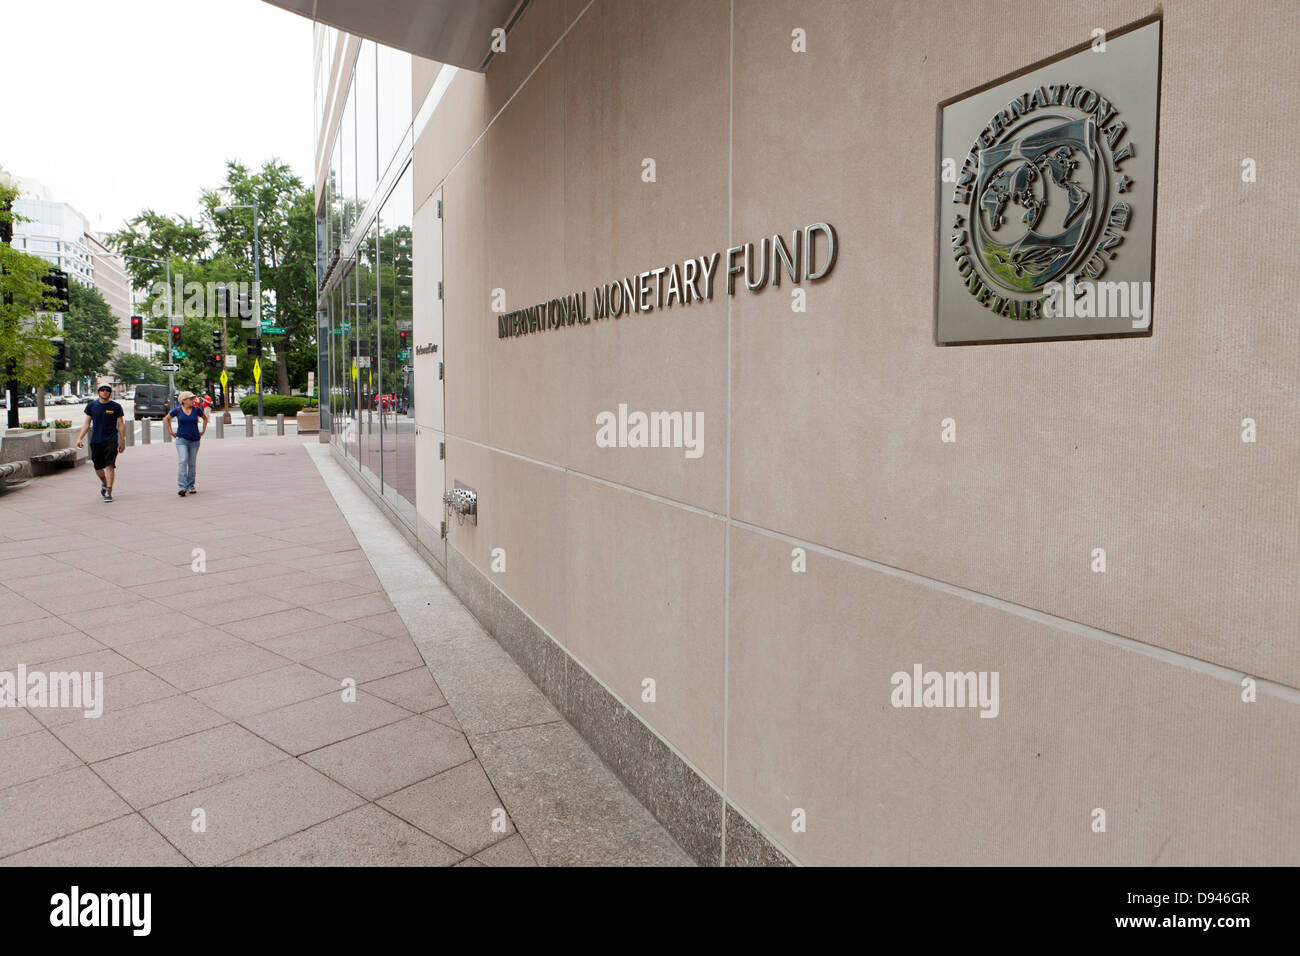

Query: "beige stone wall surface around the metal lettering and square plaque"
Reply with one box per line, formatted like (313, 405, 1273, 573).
(415, 0, 1300, 864)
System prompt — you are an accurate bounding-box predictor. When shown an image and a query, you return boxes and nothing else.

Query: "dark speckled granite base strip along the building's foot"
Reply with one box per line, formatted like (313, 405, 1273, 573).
(330, 445, 793, 866)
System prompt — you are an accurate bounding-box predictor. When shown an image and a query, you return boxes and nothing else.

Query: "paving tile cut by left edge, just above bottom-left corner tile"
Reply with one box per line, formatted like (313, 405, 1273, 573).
(0, 767, 131, 857)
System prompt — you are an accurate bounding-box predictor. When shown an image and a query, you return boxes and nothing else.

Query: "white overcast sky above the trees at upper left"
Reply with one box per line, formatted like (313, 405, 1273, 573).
(0, 0, 313, 232)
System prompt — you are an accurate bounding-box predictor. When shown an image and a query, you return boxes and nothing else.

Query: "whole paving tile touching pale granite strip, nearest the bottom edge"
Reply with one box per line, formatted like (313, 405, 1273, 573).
(377, 760, 515, 855)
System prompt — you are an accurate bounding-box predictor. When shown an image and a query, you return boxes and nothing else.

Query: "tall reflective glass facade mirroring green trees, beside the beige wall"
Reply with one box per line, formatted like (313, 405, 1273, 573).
(317, 27, 416, 528)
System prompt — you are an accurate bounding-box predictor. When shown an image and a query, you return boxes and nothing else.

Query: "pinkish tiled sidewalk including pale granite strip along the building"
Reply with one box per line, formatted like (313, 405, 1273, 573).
(0, 437, 689, 865)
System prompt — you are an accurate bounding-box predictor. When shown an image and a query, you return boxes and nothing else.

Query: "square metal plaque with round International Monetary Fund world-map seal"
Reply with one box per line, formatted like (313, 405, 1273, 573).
(935, 21, 1161, 345)
